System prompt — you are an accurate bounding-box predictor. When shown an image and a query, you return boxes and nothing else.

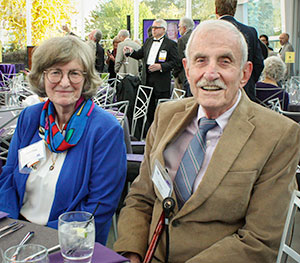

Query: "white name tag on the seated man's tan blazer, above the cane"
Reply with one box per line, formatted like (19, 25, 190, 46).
(152, 160, 173, 199)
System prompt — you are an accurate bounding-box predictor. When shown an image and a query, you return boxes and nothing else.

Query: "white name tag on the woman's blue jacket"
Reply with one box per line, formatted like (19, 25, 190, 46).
(18, 140, 46, 173)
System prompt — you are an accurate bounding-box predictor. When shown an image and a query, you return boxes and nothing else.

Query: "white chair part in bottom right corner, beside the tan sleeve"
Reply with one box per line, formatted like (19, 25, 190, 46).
(276, 190, 300, 263)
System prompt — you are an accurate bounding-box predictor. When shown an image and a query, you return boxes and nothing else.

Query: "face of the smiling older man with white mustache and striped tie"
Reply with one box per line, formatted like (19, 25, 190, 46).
(183, 30, 252, 118)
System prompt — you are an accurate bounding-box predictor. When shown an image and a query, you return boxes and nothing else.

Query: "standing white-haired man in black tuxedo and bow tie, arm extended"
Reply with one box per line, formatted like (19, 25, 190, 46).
(124, 19, 178, 124)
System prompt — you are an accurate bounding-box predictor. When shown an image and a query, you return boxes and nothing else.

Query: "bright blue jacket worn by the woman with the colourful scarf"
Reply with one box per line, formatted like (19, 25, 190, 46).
(0, 103, 126, 245)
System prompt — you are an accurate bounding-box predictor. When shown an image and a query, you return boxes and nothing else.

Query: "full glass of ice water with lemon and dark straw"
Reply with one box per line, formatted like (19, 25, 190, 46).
(58, 211, 95, 263)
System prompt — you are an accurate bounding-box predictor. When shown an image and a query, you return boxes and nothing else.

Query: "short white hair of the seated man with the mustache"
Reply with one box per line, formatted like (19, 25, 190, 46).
(185, 20, 248, 68)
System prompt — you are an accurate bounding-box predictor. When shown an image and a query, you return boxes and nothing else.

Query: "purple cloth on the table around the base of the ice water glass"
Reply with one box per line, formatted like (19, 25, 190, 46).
(49, 243, 129, 263)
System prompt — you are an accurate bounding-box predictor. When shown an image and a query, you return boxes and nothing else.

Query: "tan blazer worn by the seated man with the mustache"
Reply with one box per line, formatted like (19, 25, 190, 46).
(114, 92, 300, 263)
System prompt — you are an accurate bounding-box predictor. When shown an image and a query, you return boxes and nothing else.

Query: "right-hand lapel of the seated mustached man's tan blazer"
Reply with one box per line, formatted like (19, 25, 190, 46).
(176, 92, 255, 217)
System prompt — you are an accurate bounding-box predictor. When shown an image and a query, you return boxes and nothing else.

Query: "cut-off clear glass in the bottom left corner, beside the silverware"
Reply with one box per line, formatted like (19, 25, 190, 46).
(3, 244, 49, 263)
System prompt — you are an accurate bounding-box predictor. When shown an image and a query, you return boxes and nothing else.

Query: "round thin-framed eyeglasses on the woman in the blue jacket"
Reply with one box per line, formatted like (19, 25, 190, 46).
(44, 69, 86, 84)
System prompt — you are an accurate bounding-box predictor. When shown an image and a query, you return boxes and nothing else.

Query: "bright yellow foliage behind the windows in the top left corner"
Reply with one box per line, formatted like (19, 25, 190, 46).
(0, 0, 78, 50)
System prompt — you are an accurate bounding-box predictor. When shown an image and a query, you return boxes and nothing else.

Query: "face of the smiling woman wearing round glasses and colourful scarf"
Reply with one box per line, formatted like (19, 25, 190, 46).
(44, 60, 85, 110)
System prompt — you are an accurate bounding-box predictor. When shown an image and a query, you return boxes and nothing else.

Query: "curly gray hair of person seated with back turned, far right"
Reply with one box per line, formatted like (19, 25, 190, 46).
(262, 56, 286, 82)
